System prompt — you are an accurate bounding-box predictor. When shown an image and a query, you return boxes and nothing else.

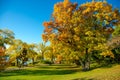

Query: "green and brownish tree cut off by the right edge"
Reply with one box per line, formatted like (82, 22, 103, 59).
(107, 25, 120, 63)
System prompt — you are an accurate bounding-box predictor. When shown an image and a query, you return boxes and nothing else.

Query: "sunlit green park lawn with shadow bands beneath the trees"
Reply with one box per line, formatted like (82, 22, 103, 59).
(0, 65, 120, 80)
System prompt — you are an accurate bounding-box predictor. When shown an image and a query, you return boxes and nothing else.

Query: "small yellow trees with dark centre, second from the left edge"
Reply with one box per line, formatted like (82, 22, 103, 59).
(6, 39, 37, 67)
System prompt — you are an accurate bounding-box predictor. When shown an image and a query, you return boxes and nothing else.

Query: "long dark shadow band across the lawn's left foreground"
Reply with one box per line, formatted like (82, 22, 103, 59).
(0, 69, 79, 77)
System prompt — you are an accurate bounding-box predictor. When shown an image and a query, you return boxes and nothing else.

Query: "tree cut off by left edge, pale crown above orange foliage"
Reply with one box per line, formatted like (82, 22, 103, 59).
(0, 29, 14, 69)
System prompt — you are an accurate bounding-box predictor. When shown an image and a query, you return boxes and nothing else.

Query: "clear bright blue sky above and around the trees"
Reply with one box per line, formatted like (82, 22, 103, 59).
(0, 0, 120, 43)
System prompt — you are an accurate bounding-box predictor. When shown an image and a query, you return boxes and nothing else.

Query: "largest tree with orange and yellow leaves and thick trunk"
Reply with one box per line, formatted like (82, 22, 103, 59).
(42, 0, 120, 70)
